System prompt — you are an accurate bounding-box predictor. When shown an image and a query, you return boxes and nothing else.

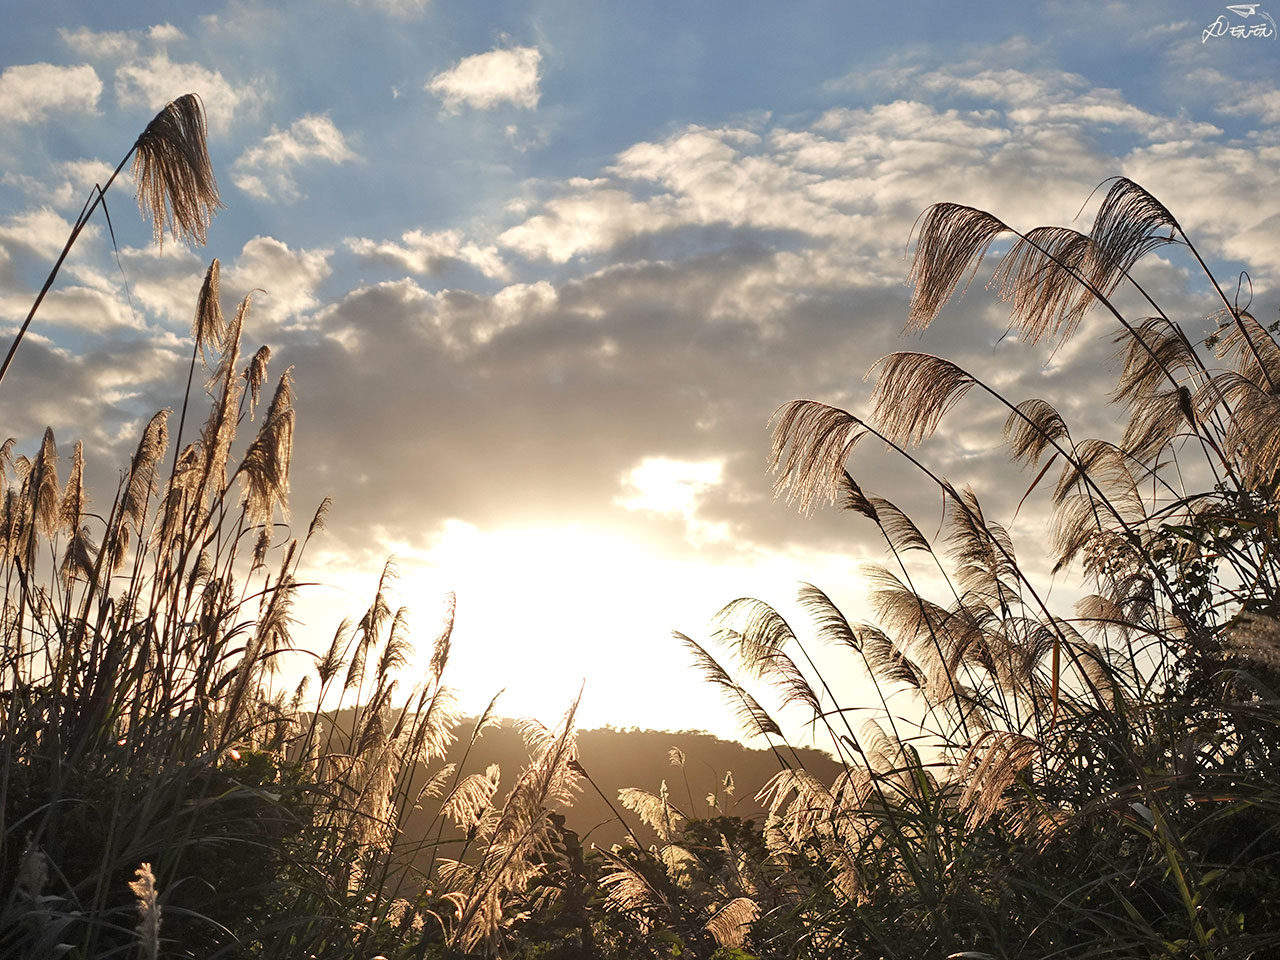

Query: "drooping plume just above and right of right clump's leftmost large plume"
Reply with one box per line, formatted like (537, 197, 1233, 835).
(872, 351, 977, 444)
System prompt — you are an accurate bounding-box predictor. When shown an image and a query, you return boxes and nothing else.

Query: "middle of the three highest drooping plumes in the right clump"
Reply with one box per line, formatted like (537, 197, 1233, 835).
(992, 227, 1094, 343)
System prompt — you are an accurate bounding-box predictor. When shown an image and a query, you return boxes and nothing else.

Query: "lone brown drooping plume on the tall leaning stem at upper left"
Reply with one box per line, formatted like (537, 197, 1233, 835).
(133, 93, 223, 246)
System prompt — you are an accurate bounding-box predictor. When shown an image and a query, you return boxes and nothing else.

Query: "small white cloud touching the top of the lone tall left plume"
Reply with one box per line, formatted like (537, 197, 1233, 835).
(115, 50, 268, 133)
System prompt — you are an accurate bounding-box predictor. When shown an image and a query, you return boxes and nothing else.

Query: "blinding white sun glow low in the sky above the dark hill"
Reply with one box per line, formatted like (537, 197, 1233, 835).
(302, 519, 860, 745)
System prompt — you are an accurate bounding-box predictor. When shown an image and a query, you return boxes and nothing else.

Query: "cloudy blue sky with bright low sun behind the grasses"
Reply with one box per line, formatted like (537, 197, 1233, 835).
(0, 0, 1280, 735)
